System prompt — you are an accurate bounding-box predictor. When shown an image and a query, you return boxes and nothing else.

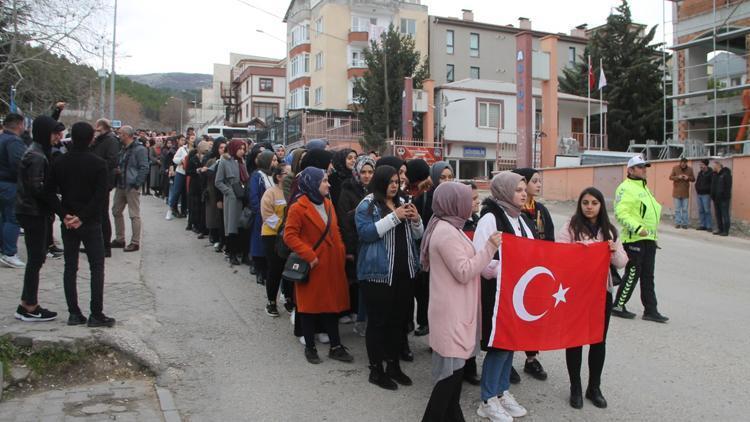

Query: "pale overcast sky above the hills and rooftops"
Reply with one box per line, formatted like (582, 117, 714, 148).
(103, 0, 671, 74)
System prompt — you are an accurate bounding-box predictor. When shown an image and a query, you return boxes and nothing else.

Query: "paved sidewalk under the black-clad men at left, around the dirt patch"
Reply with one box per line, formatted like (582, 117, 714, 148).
(0, 223, 180, 421)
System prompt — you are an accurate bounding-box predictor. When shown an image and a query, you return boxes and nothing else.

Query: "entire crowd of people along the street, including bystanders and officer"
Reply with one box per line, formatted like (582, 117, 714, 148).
(0, 108, 731, 421)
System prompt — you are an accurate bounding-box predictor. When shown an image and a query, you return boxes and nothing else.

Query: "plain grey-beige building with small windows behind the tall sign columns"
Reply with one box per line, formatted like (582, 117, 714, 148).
(430, 9, 588, 86)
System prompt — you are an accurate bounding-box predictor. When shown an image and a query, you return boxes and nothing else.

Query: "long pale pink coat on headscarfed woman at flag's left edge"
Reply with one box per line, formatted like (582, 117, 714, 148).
(427, 221, 497, 359)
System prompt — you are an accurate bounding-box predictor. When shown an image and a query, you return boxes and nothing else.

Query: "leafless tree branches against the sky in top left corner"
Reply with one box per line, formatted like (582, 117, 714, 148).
(0, 0, 106, 107)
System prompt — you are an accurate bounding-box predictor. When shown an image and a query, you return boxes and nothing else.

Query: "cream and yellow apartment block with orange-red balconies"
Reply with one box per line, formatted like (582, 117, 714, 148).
(284, 0, 428, 110)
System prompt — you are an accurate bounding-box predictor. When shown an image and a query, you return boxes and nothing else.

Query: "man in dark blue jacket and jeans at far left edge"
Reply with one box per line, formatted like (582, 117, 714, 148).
(0, 113, 26, 268)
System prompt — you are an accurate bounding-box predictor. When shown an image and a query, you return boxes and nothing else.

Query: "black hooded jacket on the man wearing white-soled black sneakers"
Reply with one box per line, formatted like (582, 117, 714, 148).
(16, 116, 62, 218)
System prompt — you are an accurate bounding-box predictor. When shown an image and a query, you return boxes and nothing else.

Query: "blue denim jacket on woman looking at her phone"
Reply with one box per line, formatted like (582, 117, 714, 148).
(354, 194, 424, 284)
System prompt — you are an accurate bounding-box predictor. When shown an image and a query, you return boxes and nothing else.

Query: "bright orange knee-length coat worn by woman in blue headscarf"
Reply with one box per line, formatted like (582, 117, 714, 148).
(284, 196, 349, 314)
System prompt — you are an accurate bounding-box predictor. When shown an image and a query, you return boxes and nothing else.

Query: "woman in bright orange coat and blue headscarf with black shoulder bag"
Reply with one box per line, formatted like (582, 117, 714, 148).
(284, 167, 354, 364)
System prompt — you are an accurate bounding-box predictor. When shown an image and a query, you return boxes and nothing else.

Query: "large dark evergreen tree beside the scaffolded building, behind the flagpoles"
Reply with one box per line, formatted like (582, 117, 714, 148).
(559, 0, 664, 151)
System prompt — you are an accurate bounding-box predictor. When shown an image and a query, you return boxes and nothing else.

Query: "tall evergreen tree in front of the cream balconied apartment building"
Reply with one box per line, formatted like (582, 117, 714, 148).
(354, 25, 429, 152)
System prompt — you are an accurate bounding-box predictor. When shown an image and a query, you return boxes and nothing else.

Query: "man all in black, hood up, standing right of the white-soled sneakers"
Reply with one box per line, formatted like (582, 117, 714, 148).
(47, 122, 115, 327)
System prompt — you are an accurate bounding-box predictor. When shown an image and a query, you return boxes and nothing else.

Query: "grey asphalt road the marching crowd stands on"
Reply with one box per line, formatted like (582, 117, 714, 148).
(141, 197, 750, 421)
